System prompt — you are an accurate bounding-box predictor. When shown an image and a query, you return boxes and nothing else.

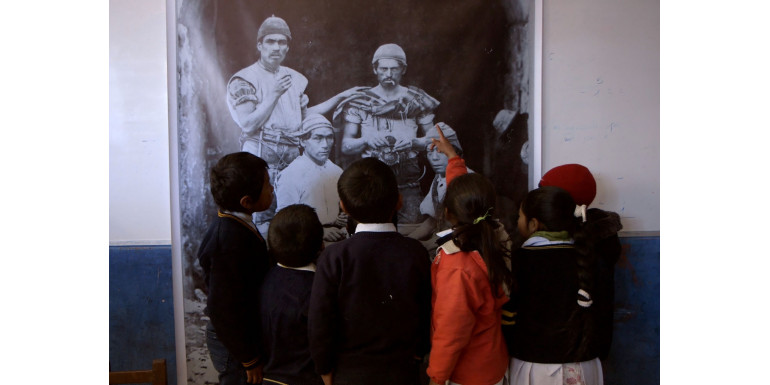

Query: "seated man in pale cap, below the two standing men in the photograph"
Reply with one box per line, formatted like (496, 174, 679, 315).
(275, 114, 347, 242)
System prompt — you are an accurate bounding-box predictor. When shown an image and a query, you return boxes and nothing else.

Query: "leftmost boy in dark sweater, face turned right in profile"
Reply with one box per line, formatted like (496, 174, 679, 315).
(198, 152, 273, 385)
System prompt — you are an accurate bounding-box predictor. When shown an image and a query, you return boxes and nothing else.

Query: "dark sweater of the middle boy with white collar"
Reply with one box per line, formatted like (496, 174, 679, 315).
(309, 232, 431, 376)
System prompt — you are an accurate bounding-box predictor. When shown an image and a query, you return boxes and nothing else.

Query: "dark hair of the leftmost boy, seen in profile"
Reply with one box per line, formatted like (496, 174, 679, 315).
(209, 152, 267, 212)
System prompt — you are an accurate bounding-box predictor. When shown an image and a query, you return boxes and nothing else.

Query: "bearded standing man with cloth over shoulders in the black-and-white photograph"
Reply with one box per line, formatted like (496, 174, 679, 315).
(335, 44, 439, 223)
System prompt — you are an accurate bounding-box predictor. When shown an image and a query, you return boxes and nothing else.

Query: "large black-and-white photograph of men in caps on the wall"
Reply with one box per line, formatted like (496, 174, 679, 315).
(167, 0, 541, 384)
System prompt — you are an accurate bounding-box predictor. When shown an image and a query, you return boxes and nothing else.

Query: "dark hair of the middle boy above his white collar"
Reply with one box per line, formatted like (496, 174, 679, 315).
(337, 158, 398, 223)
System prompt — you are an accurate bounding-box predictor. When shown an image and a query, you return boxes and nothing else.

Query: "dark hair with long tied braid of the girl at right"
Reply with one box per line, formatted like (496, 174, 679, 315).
(521, 186, 596, 355)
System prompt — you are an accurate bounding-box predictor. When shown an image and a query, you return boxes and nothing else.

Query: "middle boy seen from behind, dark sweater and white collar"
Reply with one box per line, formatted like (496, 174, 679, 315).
(309, 158, 431, 385)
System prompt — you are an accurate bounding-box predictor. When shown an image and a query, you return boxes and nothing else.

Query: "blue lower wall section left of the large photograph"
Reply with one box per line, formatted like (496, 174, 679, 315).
(110, 245, 177, 385)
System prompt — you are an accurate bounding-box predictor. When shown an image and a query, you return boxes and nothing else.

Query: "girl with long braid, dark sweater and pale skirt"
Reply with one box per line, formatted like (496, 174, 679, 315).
(507, 186, 605, 385)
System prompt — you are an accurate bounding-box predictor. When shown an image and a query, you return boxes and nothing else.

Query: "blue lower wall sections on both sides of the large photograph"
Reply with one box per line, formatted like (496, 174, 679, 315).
(110, 237, 660, 385)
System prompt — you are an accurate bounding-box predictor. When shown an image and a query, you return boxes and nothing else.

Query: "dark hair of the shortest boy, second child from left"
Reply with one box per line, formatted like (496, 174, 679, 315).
(267, 204, 324, 267)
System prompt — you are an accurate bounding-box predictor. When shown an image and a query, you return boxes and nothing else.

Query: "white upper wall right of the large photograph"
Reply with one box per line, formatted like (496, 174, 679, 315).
(542, 0, 660, 232)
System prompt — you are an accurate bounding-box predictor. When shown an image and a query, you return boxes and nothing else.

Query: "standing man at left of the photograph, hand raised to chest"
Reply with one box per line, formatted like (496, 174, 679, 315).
(227, 16, 357, 230)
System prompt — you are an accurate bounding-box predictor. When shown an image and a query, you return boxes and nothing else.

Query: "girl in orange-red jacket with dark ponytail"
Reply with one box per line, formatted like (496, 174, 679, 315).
(427, 166, 512, 385)
